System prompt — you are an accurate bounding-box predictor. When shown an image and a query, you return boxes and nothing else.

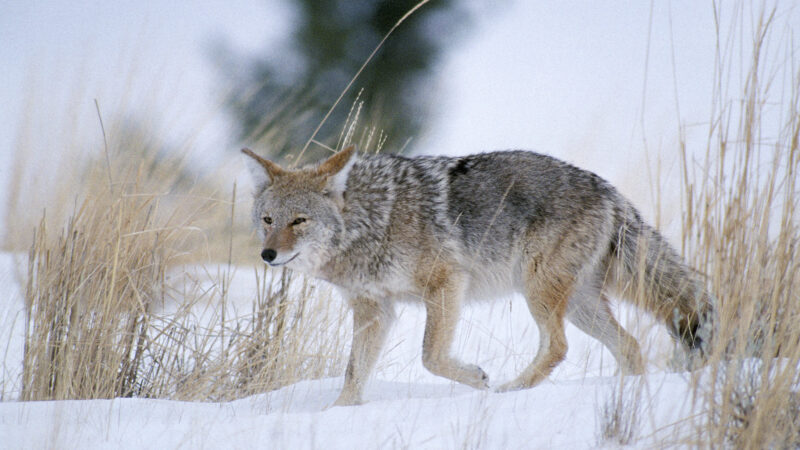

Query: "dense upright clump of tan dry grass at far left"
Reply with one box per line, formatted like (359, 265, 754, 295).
(22, 181, 187, 400)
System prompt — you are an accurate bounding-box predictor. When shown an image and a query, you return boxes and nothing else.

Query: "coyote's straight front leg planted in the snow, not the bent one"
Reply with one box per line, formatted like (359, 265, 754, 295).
(334, 297, 394, 406)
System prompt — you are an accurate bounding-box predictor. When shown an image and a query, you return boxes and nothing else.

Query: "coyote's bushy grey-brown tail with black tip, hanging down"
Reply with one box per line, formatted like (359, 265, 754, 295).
(607, 206, 714, 362)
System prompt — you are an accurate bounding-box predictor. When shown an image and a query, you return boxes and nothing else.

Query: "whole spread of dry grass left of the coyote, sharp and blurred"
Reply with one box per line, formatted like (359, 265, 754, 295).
(5, 101, 345, 400)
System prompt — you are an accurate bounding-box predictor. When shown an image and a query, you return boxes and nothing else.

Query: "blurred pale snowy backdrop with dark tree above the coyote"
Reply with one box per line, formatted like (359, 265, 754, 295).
(0, 0, 800, 243)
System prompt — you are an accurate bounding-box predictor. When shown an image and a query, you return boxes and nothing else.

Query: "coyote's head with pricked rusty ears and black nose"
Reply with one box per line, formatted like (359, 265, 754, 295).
(242, 146, 356, 274)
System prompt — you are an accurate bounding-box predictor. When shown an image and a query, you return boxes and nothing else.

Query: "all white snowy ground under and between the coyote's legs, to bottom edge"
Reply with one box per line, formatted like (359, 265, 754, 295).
(0, 254, 708, 448)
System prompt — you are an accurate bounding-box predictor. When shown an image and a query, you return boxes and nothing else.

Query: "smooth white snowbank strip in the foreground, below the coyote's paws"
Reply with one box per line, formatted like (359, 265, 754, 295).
(0, 374, 700, 449)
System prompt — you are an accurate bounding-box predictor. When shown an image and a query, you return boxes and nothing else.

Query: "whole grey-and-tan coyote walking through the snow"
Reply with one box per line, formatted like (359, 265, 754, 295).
(242, 146, 713, 405)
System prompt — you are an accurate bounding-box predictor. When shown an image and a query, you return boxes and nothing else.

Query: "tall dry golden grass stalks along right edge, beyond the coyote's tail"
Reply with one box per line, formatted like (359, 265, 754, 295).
(599, 5, 800, 448)
